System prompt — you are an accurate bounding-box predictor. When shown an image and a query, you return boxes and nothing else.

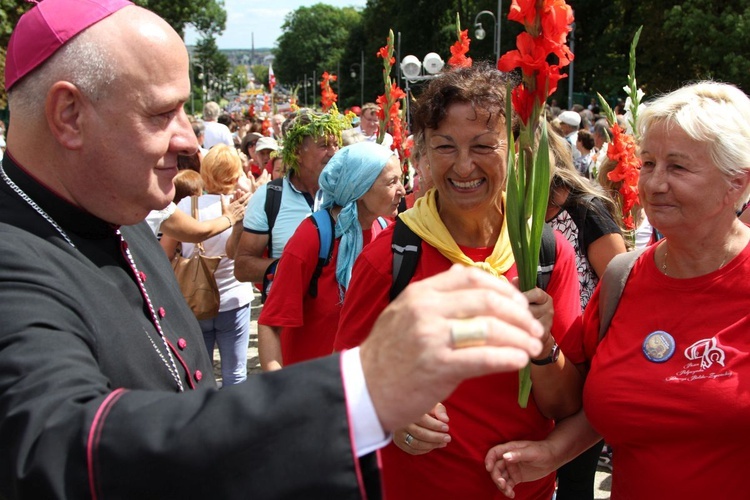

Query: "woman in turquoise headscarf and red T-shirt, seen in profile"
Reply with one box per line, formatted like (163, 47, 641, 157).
(258, 142, 405, 370)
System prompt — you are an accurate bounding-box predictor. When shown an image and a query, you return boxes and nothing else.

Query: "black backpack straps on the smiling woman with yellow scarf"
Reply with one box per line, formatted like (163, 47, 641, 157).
(389, 218, 557, 301)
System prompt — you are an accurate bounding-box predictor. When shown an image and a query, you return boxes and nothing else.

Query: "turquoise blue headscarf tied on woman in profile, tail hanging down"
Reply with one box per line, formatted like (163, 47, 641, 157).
(319, 141, 394, 291)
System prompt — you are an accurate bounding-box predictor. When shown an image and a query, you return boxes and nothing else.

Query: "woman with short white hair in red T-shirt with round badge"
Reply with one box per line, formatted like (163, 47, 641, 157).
(487, 82, 750, 500)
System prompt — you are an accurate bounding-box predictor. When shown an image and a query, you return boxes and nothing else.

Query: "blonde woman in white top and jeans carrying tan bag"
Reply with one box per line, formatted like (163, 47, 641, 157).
(162, 144, 253, 385)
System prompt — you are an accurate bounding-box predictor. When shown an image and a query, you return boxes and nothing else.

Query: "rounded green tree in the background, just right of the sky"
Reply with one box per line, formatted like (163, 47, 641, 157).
(273, 4, 361, 106)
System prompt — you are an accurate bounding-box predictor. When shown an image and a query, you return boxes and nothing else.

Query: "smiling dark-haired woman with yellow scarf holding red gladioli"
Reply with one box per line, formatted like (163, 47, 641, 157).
(335, 65, 582, 500)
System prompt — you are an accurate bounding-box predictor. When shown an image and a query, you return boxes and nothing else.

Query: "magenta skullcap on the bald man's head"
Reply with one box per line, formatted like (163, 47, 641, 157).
(5, 0, 133, 91)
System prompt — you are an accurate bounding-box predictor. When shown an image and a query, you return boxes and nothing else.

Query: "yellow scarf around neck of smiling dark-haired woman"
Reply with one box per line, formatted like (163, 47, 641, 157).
(399, 188, 515, 279)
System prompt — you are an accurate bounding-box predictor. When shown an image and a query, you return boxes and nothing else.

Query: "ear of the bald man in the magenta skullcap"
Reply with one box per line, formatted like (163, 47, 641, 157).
(44, 81, 85, 149)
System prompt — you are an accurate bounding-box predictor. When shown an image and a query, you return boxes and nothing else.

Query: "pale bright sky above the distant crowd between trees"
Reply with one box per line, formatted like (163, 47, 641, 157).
(185, 0, 367, 49)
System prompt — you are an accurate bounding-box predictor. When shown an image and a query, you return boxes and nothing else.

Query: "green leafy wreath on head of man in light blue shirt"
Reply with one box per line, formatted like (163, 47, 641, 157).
(281, 104, 351, 172)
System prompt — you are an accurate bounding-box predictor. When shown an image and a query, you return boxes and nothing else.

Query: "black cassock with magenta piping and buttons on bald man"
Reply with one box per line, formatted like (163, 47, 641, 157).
(0, 152, 379, 499)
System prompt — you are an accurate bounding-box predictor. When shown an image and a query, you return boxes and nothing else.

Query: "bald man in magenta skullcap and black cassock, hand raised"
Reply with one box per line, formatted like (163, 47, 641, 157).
(0, 0, 542, 499)
